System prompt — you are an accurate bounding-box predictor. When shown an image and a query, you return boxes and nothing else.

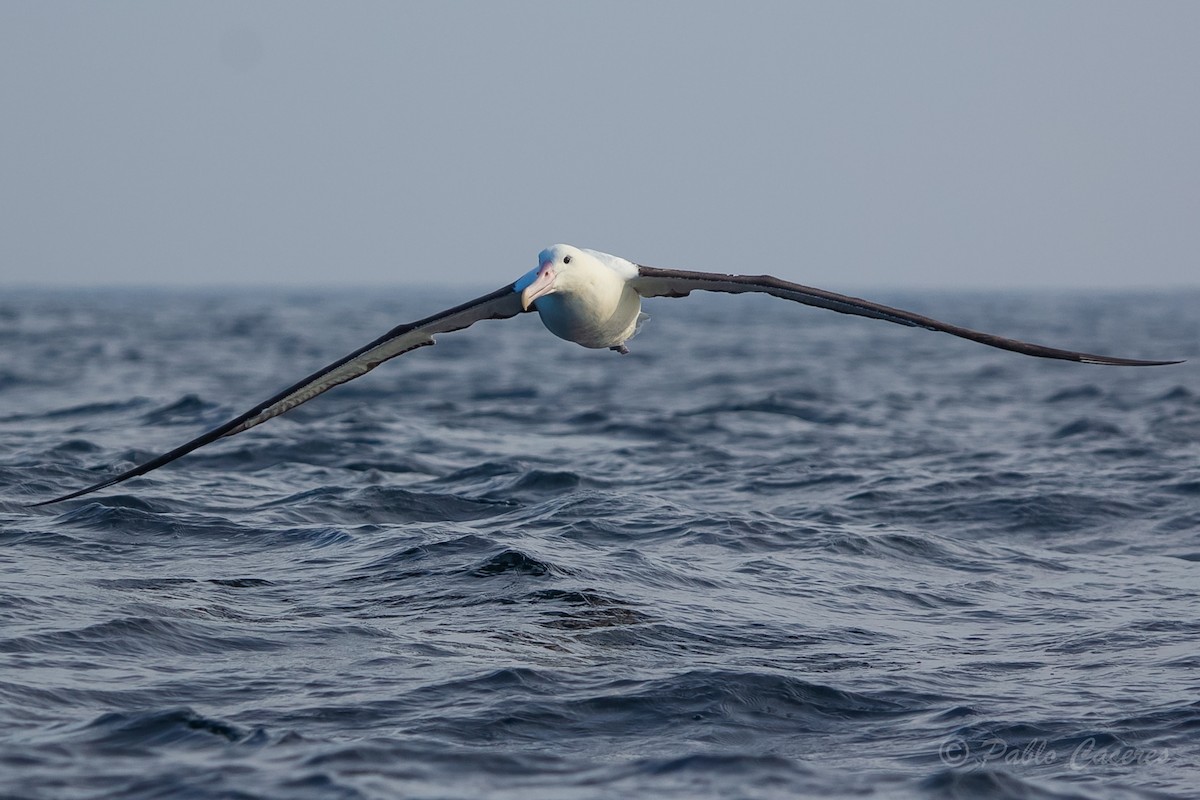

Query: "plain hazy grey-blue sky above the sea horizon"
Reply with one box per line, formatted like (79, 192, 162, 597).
(0, 0, 1200, 290)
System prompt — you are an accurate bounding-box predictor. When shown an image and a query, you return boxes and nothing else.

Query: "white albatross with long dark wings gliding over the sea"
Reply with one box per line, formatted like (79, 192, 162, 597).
(32, 245, 1180, 506)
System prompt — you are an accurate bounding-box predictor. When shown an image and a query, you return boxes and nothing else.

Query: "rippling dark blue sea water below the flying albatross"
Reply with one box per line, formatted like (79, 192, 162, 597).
(0, 289, 1200, 800)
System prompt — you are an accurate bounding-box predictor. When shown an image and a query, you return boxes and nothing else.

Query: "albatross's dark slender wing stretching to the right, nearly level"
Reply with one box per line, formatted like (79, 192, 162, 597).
(632, 265, 1181, 367)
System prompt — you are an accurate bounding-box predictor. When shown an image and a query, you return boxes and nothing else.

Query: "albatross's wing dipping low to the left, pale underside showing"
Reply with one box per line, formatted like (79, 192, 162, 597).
(32, 283, 522, 506)
